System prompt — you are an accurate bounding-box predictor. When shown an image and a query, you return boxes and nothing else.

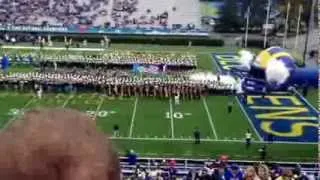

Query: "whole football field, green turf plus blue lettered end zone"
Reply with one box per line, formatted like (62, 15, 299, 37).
(0, 44, 318, 162)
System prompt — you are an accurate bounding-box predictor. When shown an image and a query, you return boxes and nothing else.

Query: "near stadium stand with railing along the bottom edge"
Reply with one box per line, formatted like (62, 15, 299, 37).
(120, 157, 319, 180)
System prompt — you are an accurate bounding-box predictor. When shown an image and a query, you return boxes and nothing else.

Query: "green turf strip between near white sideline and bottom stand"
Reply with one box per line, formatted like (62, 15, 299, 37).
(114, 140, 318, 162)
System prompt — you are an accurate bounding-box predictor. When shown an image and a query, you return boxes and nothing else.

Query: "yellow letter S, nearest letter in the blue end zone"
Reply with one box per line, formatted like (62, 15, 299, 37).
(261, 122, 318, 137)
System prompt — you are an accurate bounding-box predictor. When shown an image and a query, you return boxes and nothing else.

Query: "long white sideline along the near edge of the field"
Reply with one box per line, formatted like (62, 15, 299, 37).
(108, 137, 318, 145)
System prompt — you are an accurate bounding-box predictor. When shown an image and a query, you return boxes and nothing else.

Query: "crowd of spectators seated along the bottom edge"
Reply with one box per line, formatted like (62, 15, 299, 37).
(121, 157, 320, 180)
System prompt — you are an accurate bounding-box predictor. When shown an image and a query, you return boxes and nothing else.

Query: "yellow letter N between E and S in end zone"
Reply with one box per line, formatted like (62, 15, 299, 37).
(250, 106, 318, 120)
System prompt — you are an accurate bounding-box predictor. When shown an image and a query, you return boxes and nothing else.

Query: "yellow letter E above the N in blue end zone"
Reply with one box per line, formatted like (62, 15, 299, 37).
(247, 96, 303, 106)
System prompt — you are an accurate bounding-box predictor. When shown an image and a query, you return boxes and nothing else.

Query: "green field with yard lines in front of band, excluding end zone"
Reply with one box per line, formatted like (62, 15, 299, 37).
(0, 91, 317, 161)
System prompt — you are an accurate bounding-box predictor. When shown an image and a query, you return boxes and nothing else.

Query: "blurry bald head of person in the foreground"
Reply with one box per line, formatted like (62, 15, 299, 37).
(0, 109, 120, 180)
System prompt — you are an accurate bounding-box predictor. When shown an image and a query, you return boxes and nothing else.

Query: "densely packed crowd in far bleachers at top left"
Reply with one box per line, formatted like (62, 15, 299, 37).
(0, 0, 110, 25)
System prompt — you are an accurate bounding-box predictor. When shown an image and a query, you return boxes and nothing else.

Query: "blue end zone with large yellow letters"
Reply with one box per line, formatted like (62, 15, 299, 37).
(212, 53, 319, 143)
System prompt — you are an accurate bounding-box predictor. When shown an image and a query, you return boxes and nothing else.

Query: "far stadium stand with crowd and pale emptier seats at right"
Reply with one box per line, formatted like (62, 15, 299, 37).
(0, 0, 200, 28)
